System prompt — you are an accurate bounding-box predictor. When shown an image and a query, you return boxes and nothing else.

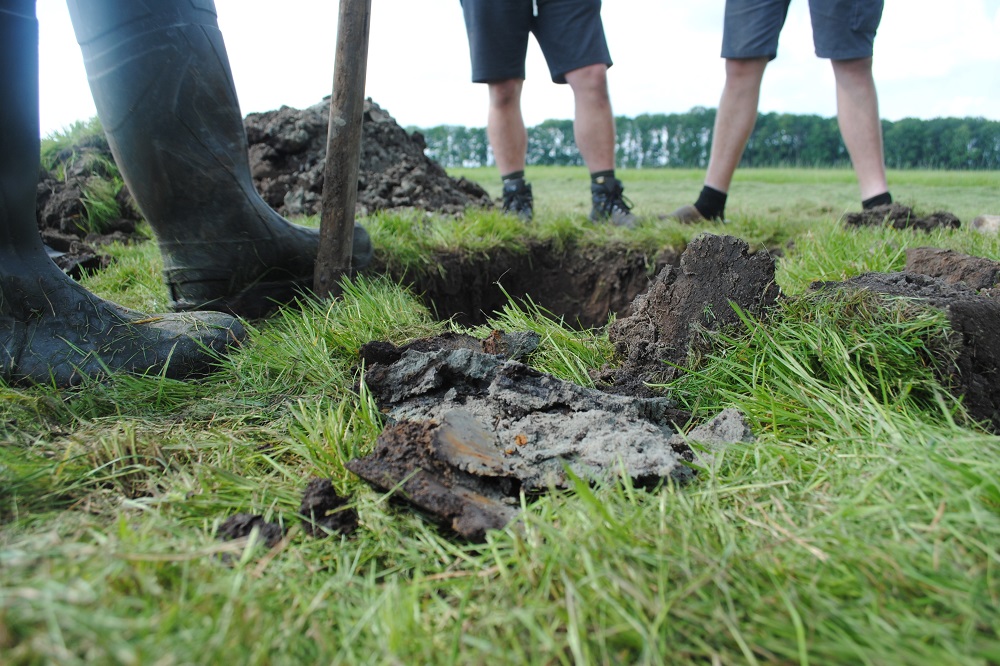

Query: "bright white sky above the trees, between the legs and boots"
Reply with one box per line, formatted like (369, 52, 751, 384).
(37, 0, 1000, 136)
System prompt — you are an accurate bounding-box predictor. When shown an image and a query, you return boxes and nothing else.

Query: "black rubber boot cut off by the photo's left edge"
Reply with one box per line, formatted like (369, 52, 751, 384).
(0, 0, 245, 387)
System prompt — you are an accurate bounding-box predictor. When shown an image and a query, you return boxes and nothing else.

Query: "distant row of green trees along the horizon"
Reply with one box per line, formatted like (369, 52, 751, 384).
(410, 107, 1000, 170)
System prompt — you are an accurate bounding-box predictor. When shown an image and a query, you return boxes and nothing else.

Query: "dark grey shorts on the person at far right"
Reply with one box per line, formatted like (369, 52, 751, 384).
(722, 0, 884, 60)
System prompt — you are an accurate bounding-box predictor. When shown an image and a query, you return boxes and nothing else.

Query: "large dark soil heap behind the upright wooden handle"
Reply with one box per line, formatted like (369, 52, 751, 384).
(245, 98, 493, 216)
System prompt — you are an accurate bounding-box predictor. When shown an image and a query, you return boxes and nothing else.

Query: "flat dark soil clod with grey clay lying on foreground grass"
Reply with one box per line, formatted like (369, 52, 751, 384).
(347, 332, 752, 540)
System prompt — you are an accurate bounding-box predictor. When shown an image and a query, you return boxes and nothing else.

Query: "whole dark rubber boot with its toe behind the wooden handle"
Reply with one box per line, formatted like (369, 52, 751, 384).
(69, 0, 372, 317)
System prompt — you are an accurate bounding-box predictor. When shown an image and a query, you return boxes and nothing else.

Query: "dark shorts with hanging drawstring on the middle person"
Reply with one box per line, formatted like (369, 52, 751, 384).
(461, 0, 611, 83)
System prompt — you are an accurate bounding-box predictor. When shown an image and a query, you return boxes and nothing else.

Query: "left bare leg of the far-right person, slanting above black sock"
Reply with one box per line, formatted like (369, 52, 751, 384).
(705, 58, 767, 192)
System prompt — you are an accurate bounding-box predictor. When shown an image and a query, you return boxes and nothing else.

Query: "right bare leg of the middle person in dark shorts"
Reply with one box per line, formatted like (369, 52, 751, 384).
(566, 64, 615, 173)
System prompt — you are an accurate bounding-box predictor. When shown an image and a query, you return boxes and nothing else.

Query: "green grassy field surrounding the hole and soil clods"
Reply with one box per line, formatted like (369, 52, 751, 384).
(0, 168, 1000, 665)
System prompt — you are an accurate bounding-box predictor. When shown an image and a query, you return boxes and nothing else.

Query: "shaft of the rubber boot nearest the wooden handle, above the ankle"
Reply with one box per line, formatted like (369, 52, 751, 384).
(69, 0, 255, 236)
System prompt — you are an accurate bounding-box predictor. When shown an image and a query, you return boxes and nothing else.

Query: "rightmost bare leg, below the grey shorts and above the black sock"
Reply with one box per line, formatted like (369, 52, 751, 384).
(831, 58, 889, 200)
